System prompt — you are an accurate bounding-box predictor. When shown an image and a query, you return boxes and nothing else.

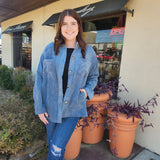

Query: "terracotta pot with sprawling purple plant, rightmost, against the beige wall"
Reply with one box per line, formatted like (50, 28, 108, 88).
(107, 85, 159, 158)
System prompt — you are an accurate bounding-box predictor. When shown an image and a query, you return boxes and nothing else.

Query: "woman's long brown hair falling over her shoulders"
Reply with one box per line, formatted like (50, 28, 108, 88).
(54, 9, 86, 58)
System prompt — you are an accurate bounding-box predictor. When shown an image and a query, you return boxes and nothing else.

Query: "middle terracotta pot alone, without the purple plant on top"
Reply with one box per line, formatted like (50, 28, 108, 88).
(82, 94, 109, 144)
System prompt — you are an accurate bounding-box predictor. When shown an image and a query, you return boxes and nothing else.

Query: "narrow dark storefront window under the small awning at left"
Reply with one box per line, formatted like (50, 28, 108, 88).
(13, 30, 32, 70)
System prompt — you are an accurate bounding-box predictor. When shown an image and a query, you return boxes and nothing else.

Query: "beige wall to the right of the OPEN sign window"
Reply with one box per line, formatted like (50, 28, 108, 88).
(120, 0, 160, 154)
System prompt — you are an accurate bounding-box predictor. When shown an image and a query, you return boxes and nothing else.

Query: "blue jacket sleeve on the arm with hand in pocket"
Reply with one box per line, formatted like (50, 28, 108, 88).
(84, 47, 99, 100)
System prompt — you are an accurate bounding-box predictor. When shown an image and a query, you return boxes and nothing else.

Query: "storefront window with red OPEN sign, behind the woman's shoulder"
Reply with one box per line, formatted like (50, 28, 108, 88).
(83, 15, 125, 82)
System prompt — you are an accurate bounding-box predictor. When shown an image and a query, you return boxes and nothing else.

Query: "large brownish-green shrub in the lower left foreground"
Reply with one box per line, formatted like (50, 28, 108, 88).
(0, 96, 45, 155)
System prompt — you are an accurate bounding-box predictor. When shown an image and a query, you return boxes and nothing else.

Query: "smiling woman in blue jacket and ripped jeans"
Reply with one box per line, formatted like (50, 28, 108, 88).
(34, 9, 99, 160)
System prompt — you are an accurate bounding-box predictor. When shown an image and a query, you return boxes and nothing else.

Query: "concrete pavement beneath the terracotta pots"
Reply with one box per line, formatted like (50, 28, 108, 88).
(40, 139, 160, 160)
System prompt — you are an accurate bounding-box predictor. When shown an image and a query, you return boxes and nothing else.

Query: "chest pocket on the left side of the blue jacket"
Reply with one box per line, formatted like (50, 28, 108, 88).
(43, 59, 56, 79)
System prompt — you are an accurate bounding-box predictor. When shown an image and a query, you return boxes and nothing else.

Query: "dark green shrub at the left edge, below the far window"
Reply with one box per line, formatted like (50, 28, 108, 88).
(0, 65, 13, 89)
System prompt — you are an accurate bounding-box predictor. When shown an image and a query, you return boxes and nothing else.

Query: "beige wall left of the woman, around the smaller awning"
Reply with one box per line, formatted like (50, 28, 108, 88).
(1, 0, 100, 73)
